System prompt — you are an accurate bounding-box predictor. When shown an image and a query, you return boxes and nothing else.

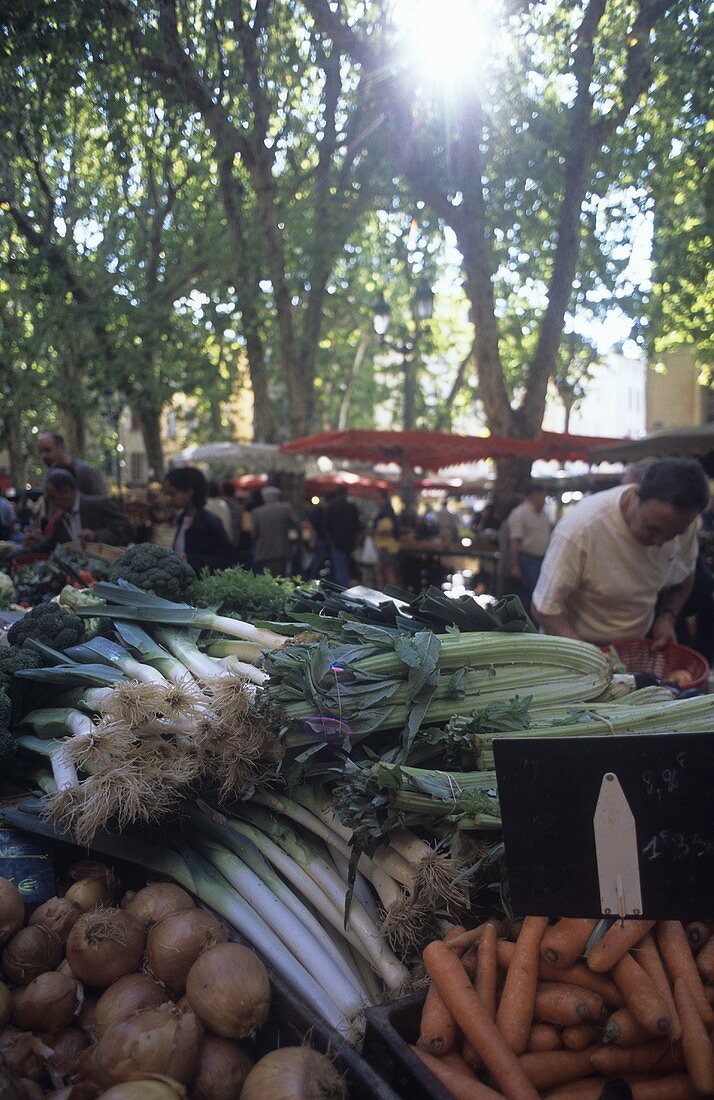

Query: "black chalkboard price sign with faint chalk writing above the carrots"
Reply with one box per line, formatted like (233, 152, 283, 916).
(494, 733, 714, 921)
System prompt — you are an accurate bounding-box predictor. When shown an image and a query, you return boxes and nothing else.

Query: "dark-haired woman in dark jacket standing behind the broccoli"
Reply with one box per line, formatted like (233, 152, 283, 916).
(164, 466, 234, 573)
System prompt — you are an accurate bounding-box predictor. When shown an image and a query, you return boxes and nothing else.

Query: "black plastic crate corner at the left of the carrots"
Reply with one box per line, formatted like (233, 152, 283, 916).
(362, 992, 452, 1100)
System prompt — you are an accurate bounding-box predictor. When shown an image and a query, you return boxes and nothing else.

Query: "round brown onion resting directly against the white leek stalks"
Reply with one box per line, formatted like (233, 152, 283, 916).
(186, 944, 271, 1038)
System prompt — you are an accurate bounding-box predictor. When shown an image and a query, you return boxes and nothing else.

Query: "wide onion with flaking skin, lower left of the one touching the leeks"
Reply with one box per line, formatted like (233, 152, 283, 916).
(95, 1004, 201, 1088)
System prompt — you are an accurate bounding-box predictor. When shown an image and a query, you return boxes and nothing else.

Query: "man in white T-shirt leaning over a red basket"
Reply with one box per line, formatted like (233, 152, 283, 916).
(532, 459, 708, 649)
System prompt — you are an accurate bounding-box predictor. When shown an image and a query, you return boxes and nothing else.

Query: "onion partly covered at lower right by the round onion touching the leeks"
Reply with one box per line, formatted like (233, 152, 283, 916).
(146, 909, 228, 993)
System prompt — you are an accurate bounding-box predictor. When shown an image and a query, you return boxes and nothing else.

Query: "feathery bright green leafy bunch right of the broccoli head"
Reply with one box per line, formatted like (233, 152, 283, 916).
(188, 565, 295, 623)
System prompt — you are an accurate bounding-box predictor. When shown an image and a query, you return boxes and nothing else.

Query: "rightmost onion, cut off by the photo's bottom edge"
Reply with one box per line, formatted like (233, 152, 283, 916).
(241, 1046, 347, 1100)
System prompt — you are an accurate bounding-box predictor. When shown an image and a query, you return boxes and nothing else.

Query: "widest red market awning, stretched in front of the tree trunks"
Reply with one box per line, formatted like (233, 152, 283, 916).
(281, 428, 622, 470)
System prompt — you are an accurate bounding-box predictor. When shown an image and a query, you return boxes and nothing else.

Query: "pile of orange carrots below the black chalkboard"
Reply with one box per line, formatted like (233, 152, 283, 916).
(413, 916, 714, 1100)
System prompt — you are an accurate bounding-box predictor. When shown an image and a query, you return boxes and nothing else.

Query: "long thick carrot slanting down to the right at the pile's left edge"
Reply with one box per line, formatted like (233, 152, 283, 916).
(422, 941, 538, 1100)
